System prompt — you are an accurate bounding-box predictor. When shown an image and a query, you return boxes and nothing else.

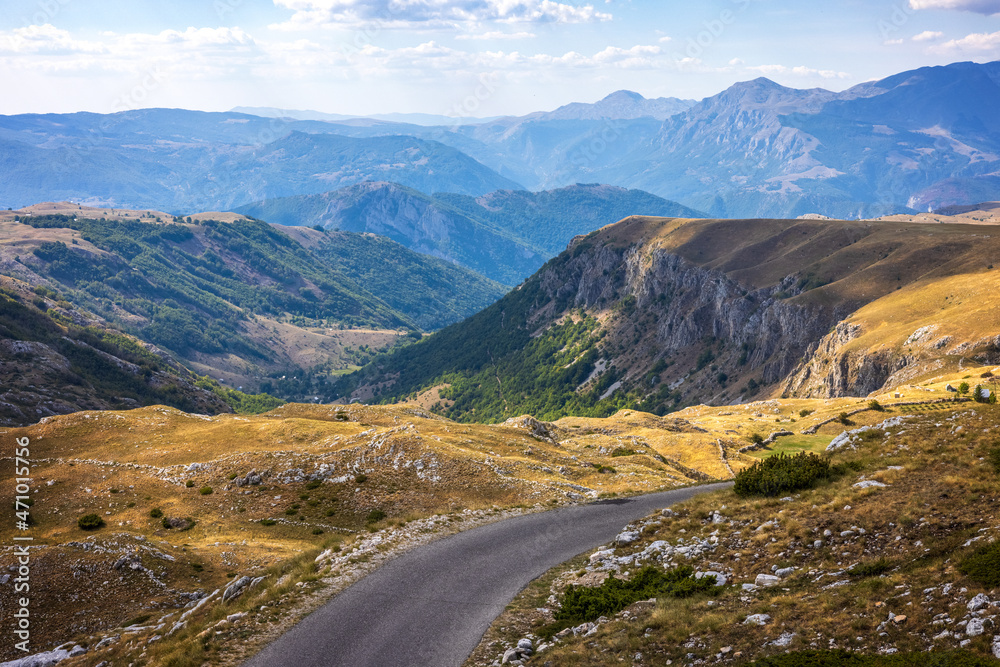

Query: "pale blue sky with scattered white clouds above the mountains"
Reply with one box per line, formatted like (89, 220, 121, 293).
(0, 0, 1000, 117)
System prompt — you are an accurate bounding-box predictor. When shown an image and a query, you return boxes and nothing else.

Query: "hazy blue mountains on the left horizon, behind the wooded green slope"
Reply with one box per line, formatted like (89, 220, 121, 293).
(0, 109, 521, 212)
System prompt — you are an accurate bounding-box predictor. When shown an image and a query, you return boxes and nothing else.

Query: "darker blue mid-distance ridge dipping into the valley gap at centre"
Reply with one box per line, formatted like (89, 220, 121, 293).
(235, 182, 704, 285)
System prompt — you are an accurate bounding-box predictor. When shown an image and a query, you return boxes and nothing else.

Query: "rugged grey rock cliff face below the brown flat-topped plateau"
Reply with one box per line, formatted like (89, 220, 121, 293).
(536, 240, 838, 402)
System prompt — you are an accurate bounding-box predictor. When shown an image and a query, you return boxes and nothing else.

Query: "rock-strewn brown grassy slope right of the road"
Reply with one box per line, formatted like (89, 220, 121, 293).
(468, 388, 1000, 666)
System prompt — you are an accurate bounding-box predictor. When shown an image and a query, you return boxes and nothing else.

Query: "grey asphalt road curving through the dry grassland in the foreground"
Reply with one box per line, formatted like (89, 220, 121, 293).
(243, 482, 731, 667)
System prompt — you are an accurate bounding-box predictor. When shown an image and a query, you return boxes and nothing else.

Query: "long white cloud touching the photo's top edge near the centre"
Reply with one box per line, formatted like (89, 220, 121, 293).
(270, 0, 612, 30)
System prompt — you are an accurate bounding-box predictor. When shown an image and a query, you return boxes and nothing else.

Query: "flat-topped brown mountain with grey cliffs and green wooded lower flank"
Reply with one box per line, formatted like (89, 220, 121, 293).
(338, 217, 1000, 421)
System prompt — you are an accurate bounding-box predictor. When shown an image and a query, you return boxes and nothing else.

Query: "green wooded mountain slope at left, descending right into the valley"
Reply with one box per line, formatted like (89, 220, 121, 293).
(0, 215, 503, 394)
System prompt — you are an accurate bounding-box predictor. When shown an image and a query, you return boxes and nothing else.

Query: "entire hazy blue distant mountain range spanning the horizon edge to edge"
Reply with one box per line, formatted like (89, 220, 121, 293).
(0, 62, 1000, 217)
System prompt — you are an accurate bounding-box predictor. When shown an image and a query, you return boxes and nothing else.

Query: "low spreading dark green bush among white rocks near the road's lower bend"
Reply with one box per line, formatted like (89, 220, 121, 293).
(541, 565, 722, 637)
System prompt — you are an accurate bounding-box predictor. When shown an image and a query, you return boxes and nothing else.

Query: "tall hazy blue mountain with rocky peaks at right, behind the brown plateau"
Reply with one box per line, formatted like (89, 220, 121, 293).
(595, 63, 1000, 217)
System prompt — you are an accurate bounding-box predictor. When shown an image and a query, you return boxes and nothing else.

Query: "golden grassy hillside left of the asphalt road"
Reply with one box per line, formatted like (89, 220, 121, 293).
(0, 404, 739, 664)
